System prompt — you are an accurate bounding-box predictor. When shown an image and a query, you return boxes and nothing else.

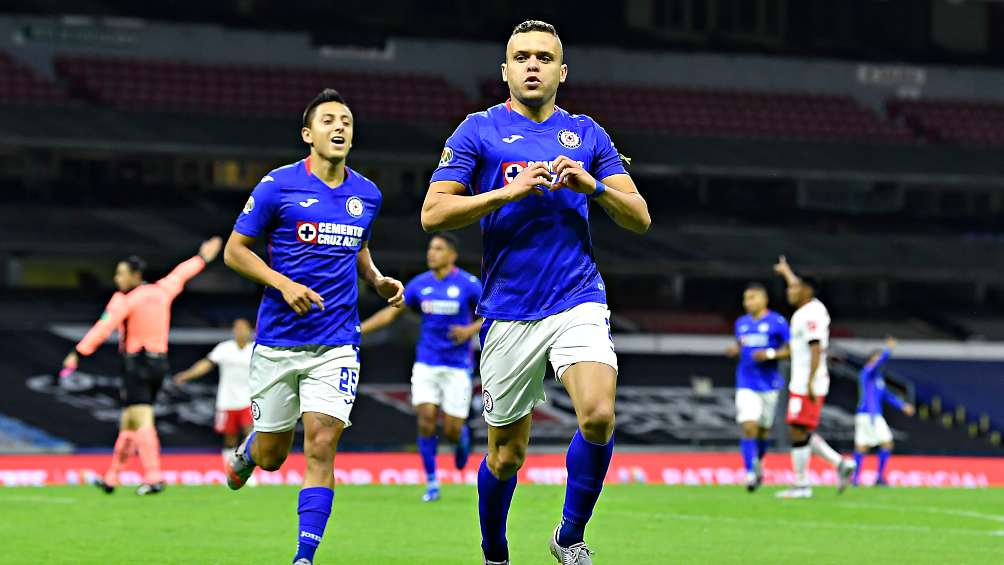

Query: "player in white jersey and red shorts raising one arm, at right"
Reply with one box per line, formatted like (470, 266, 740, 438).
(774, 255, 854, 498)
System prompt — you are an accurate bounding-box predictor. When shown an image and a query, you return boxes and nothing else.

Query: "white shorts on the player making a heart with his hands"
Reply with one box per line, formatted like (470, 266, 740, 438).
(481, 302, 617, 428)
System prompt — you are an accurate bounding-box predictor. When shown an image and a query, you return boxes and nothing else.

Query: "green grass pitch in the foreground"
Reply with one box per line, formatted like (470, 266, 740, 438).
(0, 485, 1004, 565)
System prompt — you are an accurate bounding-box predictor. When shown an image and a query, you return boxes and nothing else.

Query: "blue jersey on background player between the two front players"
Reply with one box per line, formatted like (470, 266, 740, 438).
(405, 268, 481, 369)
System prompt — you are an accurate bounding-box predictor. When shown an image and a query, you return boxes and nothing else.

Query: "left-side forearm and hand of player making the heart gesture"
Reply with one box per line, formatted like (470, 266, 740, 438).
(422, 164, 551, 233)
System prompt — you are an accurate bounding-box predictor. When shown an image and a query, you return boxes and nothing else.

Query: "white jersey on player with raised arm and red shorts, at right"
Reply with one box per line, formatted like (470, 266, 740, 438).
(788, 298, 829, 396)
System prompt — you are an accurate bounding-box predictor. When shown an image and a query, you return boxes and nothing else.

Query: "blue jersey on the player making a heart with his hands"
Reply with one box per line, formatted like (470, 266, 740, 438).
(432, 102, 626, 320)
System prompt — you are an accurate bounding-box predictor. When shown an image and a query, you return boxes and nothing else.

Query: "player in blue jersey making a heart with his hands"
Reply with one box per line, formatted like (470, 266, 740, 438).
(422, 21, 652, 565)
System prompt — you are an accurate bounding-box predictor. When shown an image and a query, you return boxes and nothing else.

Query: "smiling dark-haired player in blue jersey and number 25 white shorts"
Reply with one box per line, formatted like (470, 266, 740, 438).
(224, 88, 404, 565)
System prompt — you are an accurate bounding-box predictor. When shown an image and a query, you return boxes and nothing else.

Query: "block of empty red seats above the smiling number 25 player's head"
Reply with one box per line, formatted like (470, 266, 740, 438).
(56, 56, 470, 120)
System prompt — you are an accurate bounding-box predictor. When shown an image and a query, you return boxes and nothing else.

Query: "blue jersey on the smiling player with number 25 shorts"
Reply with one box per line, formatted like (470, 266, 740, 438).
(234, 158, 382, 347)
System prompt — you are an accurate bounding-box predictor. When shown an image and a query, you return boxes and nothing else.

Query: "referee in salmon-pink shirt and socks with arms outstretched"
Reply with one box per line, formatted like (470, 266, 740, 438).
(60, 238, 222, 495)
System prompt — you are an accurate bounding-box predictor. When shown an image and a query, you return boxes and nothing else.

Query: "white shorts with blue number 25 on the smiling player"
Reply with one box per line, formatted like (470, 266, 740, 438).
(249, 344, 359, 432)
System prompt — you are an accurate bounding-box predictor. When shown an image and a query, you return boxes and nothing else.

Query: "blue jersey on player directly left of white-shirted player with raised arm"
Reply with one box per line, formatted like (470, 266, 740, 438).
(735, 310, 789, 391)
